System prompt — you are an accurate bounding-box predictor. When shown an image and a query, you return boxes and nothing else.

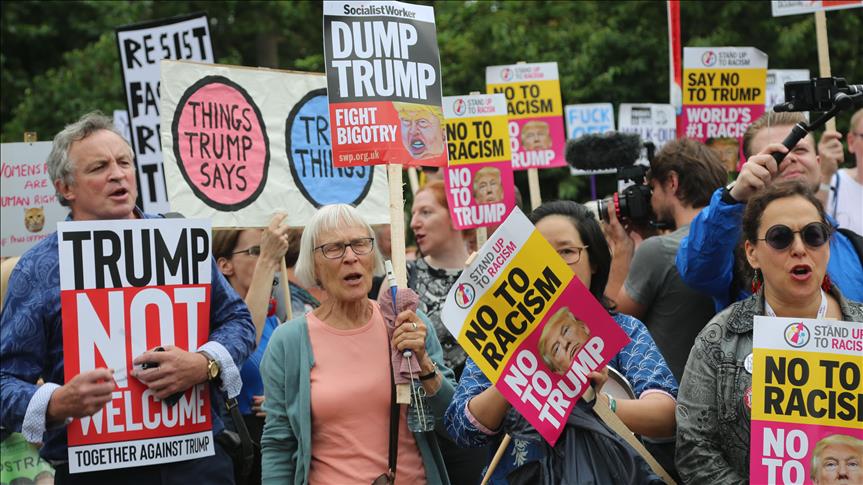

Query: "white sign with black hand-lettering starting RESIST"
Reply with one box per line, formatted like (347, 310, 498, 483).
(117, 14, 215, 213)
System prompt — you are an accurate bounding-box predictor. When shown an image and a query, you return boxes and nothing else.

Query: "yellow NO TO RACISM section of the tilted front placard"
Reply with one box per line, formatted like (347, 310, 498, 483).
(458, 230, 573, 382)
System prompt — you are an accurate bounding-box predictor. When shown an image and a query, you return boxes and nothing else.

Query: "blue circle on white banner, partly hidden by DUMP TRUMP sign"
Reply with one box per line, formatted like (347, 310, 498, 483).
(285, 89, 375, 207)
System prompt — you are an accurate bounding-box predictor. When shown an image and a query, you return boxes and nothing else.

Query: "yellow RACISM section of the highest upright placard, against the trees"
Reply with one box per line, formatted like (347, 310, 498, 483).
(486, 79, 563, 120)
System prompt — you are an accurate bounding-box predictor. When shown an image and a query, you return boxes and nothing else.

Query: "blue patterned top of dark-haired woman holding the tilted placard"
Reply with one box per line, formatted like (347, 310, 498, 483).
(445, 313, 677, 485)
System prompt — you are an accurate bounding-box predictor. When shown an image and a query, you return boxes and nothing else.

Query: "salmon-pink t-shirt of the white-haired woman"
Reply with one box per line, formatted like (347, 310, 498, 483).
(306, 302, 426, 485)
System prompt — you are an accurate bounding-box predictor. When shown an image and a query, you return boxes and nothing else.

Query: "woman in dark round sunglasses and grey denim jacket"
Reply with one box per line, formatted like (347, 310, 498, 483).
(677, 181, 863, 484)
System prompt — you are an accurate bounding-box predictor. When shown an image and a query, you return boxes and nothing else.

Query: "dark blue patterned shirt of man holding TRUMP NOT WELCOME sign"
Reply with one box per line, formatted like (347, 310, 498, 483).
(0, 212, 255, 461)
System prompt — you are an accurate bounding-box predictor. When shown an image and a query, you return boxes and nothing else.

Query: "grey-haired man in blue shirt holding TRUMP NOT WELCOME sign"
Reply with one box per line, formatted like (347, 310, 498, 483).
(0, 114, 254, 484)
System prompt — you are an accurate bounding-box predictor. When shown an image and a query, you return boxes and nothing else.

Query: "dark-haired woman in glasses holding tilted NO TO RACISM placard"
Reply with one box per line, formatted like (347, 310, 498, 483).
(446, 200, 677, 484)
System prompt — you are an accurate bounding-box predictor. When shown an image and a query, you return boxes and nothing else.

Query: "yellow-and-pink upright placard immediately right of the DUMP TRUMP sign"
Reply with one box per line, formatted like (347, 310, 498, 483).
(443, 94, 515, 229)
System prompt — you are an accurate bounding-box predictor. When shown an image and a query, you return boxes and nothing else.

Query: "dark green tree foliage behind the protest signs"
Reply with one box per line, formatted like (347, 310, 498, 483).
(0, 0, 863, 199)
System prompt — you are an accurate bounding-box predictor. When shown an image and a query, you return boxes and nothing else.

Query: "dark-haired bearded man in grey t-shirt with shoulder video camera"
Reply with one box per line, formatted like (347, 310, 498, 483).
(606, 138, 726, 380)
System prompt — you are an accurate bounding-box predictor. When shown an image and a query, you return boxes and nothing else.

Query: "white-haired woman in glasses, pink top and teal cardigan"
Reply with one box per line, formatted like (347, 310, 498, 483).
(261, 204, 454, 484)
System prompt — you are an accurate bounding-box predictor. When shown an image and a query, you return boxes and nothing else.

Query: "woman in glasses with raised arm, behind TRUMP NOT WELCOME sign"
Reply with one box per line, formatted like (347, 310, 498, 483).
(213, 214, 288, 483)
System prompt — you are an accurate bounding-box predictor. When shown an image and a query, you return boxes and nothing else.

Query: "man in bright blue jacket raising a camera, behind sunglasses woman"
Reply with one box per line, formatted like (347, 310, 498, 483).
(677, 112, 863, 311)
